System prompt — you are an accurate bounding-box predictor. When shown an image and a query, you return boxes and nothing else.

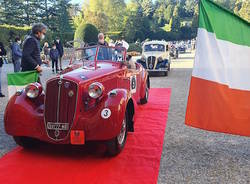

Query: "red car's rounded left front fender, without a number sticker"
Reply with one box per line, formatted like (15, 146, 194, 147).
(4, 93, 45, 137)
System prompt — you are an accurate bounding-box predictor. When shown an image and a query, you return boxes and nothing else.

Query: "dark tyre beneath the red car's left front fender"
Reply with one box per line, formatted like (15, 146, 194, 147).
(13, 136, 40, 149)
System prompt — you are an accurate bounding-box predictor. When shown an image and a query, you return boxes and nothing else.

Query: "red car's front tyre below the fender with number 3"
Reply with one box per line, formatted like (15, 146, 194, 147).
(106, 110, 129, 156)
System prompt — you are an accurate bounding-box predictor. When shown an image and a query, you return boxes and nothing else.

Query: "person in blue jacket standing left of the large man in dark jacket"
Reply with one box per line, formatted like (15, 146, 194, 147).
(11, 37, 22, 72)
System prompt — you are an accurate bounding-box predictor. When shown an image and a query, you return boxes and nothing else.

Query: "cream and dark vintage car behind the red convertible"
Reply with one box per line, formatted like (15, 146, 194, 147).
(137, 40, 171, 76)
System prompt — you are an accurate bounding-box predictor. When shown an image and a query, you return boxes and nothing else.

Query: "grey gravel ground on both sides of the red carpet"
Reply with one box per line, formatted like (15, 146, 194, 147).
(0, 53, 250, 184)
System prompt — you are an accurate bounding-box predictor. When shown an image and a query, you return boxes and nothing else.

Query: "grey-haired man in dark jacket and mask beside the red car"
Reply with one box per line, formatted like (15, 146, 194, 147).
(21, 23, 47, 72)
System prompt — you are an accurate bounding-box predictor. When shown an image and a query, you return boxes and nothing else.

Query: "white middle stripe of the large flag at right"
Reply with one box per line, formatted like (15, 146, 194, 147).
(192, 28, 250, 90)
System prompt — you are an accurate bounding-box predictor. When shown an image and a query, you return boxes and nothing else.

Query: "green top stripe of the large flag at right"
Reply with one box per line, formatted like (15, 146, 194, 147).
(199, 0, 250, 46)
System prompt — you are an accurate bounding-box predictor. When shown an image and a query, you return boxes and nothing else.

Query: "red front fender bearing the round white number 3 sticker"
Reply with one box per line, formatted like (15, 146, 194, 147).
(77, 88, 135, 140)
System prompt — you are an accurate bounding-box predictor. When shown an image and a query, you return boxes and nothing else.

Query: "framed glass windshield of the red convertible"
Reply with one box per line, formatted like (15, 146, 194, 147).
(75, 46, 126, 62)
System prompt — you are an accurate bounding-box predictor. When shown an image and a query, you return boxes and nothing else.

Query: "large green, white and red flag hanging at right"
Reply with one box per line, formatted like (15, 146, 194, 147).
(185, 0, 250, 136)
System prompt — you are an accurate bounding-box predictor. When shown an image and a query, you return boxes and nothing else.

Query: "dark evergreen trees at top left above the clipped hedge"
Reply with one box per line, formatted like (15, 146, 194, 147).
(0, 0, 74, 41)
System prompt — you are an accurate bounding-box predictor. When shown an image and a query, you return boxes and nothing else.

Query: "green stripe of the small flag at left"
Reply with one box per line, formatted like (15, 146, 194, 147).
(7, 71, 38, 86)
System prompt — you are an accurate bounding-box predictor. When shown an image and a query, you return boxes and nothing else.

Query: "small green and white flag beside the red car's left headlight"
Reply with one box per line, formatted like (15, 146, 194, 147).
(7, 71, 39, 99)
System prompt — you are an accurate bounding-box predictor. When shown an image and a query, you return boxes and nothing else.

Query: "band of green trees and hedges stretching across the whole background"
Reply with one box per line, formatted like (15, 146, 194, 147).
(0, 0, 250, 44)
